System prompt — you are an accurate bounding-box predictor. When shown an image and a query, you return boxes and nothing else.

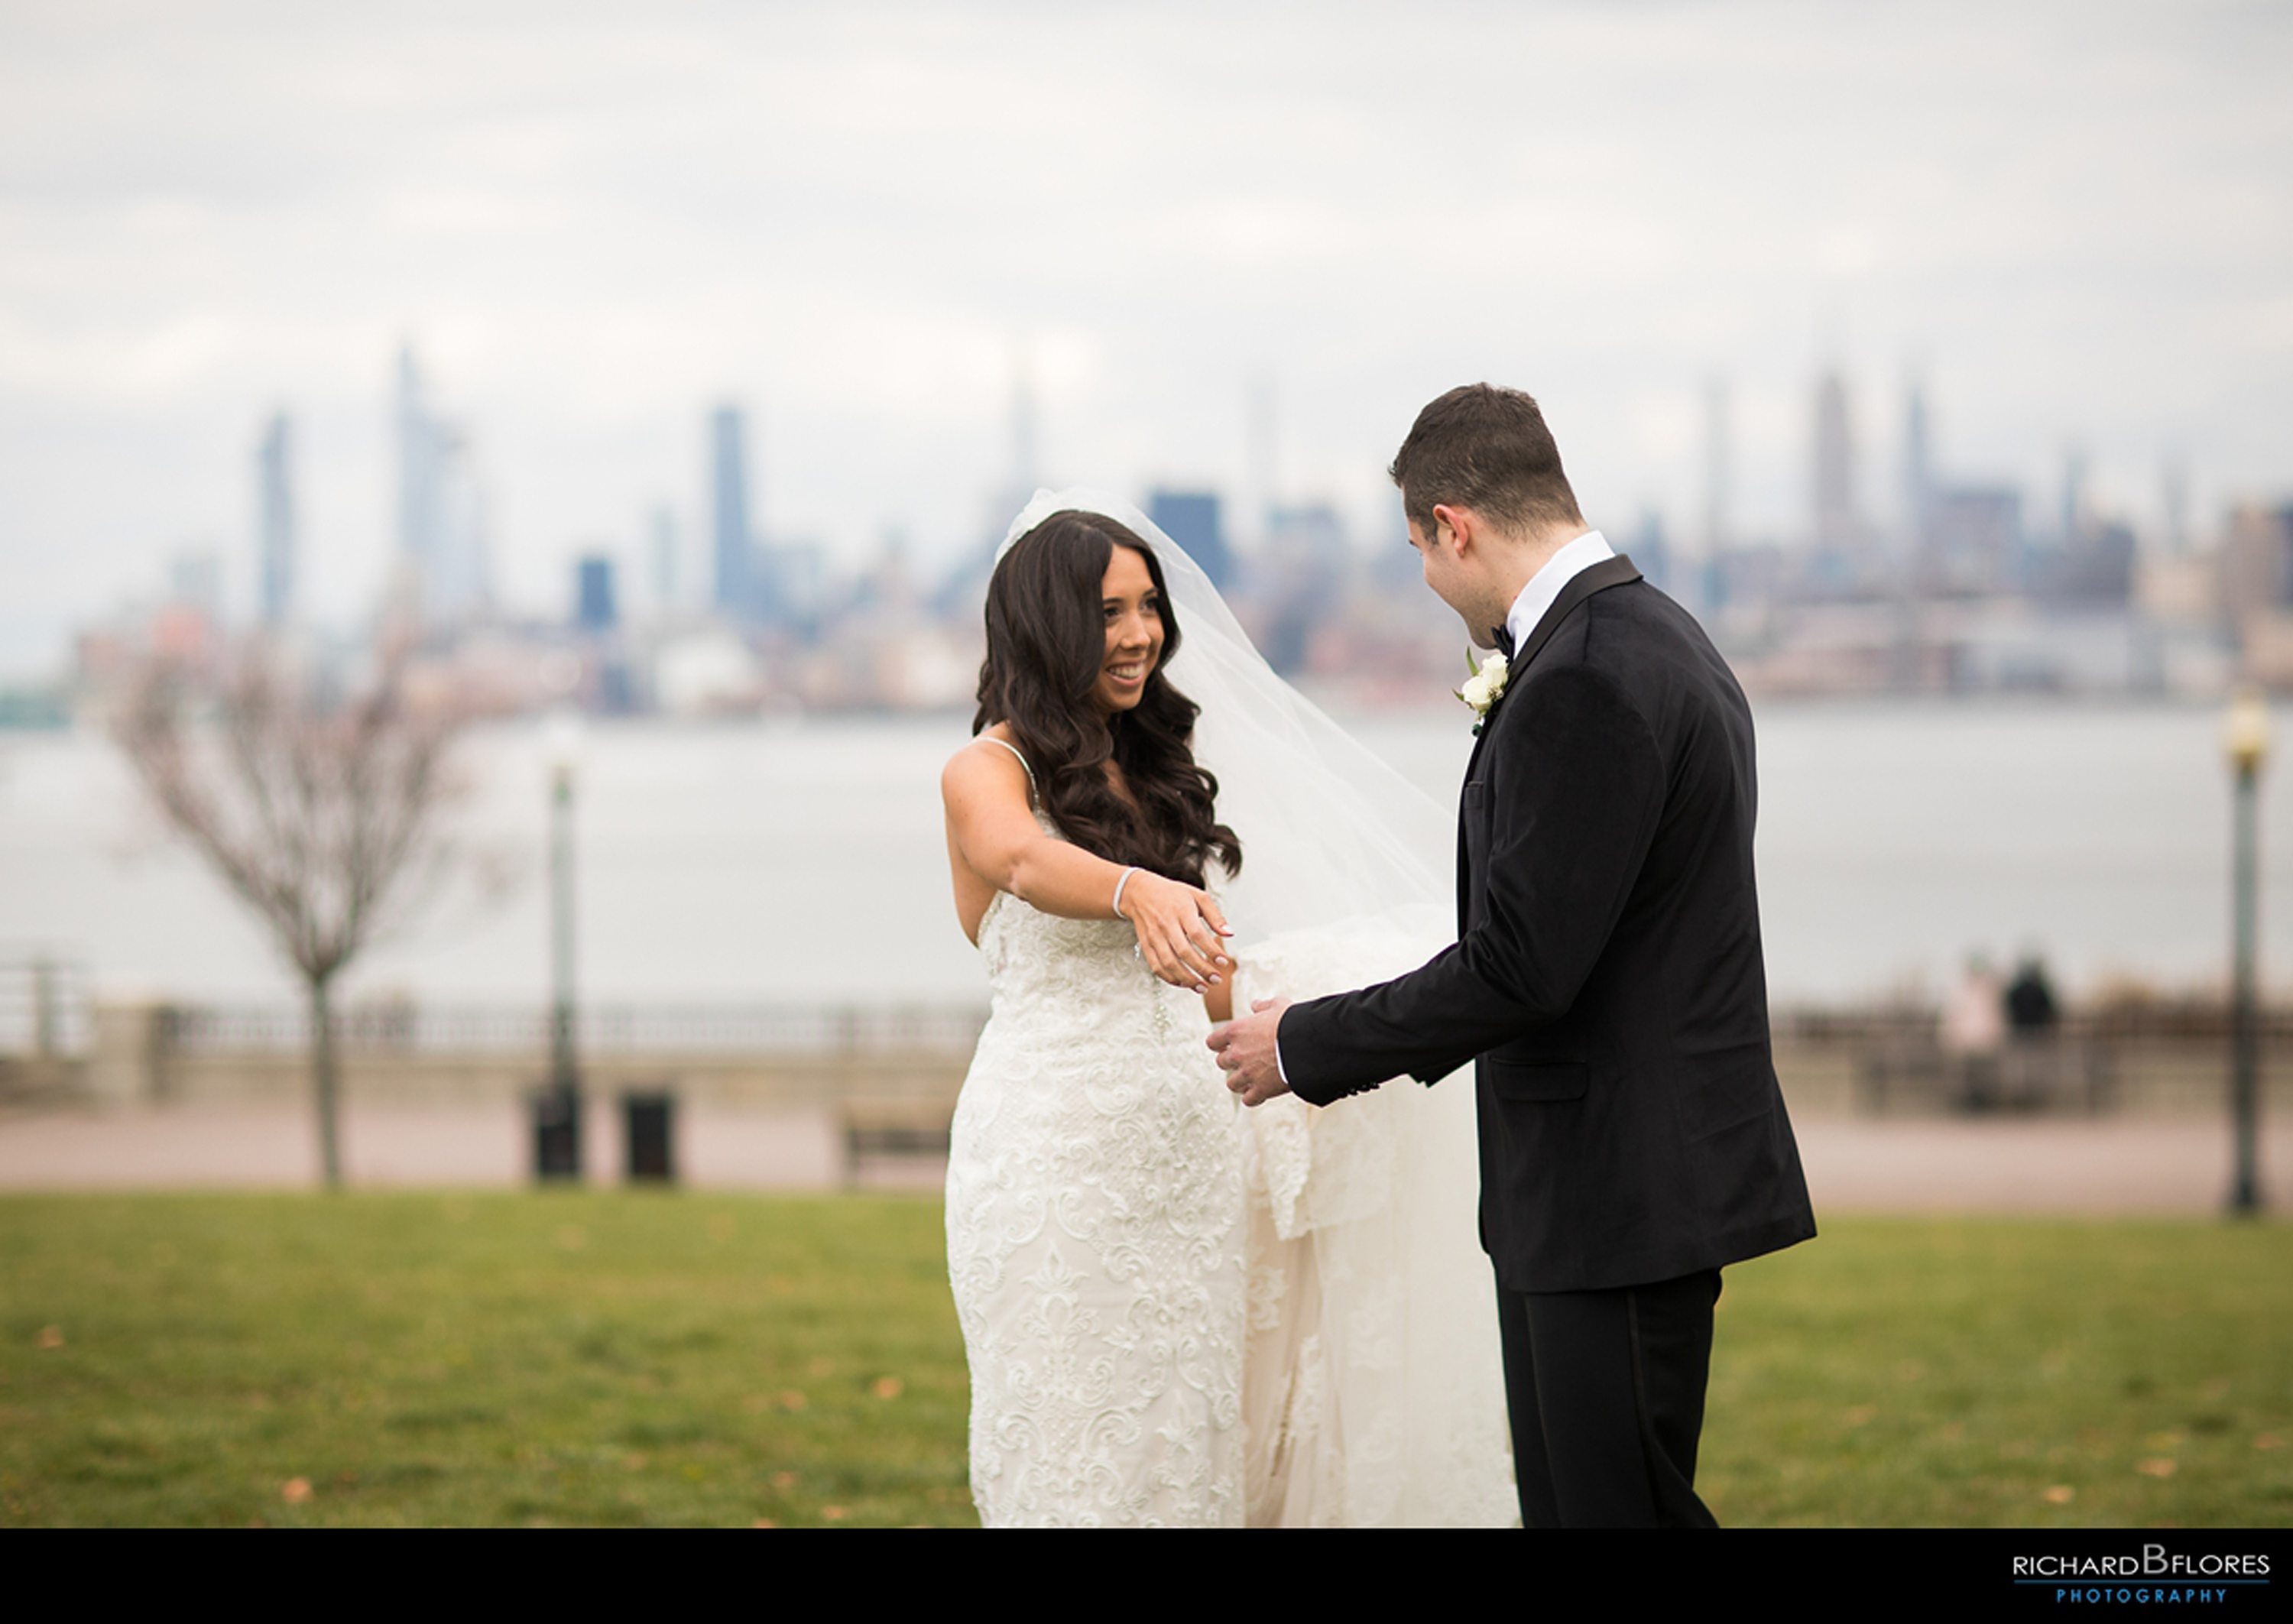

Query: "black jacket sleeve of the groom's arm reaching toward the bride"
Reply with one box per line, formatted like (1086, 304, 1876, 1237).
(1279, 665, 1665, 1106)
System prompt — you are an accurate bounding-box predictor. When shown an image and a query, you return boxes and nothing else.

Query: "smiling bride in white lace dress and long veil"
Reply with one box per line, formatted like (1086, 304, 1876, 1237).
(942, 491, 1513, 1528)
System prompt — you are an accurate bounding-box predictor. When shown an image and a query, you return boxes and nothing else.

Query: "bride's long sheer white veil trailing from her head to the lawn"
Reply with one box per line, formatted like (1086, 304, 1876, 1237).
(1004, 488, 1518, 1528)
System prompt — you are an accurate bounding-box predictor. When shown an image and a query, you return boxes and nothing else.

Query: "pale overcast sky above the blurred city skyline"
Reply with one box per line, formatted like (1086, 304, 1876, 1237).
(0, 0, 2293, 674)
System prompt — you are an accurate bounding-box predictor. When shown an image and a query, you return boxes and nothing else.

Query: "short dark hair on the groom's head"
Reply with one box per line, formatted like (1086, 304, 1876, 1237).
(1385, 383, 1584, 536)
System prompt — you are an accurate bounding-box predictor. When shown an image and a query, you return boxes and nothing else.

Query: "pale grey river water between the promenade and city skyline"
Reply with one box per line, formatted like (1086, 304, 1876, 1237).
(0, 702, 2293, 1003)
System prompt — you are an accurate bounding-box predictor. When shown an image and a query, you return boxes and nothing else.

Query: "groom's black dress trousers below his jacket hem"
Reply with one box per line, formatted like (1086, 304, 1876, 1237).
(1497, 1269, 1720, 1528)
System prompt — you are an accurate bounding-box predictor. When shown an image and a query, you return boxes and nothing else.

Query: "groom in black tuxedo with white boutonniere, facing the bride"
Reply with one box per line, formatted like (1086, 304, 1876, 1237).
(1211, 383, 1816, 1528)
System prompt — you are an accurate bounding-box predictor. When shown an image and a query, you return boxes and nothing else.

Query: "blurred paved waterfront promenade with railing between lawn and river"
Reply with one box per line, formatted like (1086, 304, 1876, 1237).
(0, 989, 2293, 1214)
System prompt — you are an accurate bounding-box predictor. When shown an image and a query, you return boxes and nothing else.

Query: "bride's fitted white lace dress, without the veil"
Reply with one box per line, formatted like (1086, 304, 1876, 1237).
(947, 741, 1245, 1528)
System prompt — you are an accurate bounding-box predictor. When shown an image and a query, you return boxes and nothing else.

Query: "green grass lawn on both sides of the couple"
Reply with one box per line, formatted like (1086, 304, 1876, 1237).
(0, 1193, 2293, 1528)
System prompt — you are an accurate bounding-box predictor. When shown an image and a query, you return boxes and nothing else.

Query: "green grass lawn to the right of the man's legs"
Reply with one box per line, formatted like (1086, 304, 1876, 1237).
(1697, 1218, 2293, 1528)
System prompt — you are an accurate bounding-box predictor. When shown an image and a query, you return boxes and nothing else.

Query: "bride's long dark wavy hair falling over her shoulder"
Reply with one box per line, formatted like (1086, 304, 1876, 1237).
(972, 509, 1243, 886)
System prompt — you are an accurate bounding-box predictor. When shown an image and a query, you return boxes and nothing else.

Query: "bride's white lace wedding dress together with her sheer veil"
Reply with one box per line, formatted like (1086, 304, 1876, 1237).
(947, 491, 1518, 1528)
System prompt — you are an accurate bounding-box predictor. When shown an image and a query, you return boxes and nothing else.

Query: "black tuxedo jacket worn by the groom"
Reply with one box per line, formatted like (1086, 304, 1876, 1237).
(1279, 557, 1816, 1292)
